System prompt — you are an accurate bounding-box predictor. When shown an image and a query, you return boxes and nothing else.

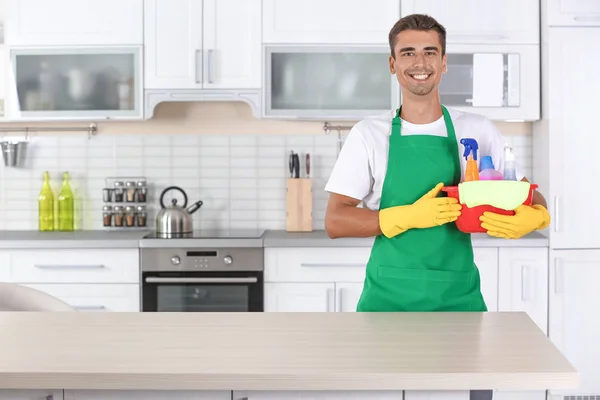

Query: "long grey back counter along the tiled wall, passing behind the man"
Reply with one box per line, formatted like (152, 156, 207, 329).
(0, 230, 548, 249)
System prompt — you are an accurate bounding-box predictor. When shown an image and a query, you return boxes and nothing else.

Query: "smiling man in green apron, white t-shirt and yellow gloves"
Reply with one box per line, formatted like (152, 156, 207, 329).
(325, 15, 550, 399)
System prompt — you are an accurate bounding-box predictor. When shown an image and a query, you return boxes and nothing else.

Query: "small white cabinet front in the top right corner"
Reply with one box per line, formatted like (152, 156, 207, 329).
(546, 0, 600, 26)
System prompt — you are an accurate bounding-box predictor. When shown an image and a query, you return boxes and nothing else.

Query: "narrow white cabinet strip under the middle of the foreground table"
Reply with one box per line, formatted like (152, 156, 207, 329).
(232, 390, 403, 400)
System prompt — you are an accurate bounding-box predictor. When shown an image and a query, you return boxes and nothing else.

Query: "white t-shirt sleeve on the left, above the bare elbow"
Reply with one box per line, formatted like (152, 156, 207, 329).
(325, 126, 372, 201)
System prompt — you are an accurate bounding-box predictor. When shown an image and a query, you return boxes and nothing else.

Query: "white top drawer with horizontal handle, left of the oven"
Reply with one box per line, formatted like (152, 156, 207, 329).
(8, 249, 140, 283)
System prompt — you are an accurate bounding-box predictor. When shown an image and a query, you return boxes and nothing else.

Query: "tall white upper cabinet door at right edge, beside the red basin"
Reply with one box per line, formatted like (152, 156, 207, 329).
(542, 28, 600, 249)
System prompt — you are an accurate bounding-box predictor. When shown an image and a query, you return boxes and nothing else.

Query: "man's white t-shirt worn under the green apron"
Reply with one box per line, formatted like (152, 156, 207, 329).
(325, 108, 523, 210)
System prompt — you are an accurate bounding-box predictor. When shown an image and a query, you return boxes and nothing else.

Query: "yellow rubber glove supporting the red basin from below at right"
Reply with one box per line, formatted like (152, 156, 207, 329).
(479, 204, 550, 239)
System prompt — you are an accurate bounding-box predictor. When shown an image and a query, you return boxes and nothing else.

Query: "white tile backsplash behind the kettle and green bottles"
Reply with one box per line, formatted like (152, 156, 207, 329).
(0, 134, 531, 229)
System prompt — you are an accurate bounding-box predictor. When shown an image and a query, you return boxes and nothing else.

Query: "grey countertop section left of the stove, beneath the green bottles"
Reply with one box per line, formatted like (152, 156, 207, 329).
(0, 230, 150, 249)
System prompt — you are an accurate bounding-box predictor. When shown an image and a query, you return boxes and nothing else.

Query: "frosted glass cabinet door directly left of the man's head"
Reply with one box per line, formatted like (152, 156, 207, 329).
(265, 47, 399, 119)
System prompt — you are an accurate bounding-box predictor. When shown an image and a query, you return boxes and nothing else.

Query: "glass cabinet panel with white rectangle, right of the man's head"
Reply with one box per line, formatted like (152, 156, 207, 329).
(439, 53, 521, 107)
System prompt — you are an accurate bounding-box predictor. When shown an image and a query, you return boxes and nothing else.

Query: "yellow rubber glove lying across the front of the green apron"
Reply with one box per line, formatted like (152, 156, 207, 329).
(379, 182, 462, 238)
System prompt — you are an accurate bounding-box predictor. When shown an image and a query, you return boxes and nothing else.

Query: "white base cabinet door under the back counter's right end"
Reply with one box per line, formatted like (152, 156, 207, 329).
(498, 247, 548, 334)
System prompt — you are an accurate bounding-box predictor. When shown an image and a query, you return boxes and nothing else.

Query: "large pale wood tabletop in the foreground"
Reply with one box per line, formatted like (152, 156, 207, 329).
(0, 312, 579, 391)
